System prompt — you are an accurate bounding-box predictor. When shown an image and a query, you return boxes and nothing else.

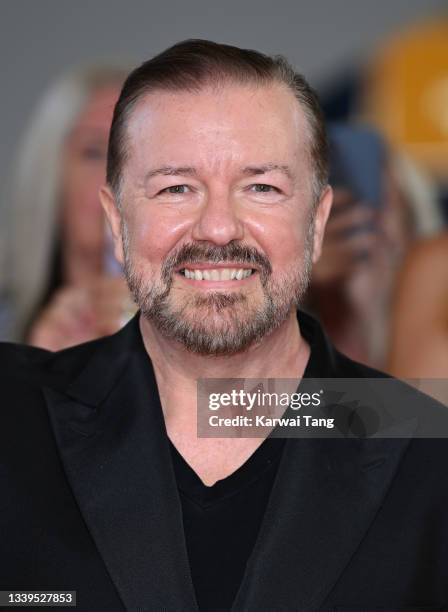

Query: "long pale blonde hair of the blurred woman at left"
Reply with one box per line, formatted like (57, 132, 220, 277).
(2, 65, 128, 340)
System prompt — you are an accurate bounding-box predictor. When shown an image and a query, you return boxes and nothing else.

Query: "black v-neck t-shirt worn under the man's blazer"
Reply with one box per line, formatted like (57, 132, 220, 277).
(170, 438, 285, 612)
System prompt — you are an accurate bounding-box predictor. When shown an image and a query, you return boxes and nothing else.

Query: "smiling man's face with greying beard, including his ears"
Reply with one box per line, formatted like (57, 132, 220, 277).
(104, 85, 331, 354)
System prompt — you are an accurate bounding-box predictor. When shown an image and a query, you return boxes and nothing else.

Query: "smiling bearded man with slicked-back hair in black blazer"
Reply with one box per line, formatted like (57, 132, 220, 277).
(1, 41, 448, 612)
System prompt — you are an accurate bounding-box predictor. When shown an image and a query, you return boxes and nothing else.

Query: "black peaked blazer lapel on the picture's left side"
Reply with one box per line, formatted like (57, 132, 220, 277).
(44, 321, 198, 612)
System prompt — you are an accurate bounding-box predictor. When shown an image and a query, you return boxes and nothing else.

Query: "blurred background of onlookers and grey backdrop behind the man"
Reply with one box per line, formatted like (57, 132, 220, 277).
(0, 0, 448, 396)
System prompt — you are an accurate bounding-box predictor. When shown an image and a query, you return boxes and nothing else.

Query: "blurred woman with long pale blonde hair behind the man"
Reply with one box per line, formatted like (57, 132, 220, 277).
(0, 66, 129, 350)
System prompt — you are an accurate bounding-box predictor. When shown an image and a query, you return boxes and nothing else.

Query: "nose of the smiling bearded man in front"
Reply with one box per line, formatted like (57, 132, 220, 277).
(192, 193, 244, 245)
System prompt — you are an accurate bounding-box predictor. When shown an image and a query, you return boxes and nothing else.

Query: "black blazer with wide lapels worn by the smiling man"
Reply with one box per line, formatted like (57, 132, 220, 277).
(0, 315, 448, 612)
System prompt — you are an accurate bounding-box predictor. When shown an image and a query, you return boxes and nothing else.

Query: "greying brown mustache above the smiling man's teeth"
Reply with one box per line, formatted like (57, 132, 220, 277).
(162, 242, 272, 283)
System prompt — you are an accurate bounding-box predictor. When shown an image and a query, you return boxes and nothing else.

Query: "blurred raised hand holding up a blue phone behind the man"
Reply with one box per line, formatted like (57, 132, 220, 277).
(310, 189, 401, 367)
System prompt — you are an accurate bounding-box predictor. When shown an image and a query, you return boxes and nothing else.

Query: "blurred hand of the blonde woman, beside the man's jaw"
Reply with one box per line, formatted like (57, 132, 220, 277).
(28, 276, 135, 351)
